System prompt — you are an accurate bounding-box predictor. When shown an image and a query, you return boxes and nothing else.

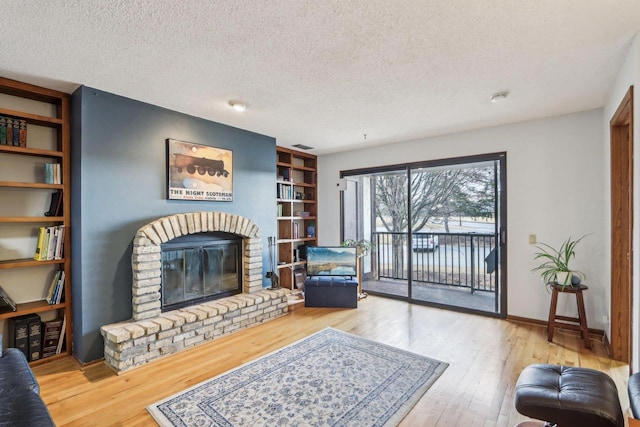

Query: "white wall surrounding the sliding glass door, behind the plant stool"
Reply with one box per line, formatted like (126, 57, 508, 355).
(318, 109, 604, 329)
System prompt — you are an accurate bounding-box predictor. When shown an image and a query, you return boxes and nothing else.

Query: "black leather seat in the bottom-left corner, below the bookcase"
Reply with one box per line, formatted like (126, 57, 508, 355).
(0, 348, 55, 427)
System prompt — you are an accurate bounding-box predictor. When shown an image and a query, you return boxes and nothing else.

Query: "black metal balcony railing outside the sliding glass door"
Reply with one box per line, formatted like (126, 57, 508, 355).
(372, 232, 499, 292)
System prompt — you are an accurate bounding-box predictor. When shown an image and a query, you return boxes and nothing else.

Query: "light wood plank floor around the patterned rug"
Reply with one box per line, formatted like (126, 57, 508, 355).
(34, 296, 629, 427)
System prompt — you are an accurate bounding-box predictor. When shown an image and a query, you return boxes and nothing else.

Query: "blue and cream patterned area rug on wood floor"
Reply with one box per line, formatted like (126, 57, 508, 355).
(147, 328, 448, 427)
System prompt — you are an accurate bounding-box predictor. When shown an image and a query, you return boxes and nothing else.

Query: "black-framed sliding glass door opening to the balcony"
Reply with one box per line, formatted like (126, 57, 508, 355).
(342, 153, 506, 316)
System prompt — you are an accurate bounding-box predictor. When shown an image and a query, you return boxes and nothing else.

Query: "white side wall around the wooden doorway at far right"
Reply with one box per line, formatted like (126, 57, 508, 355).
(603, 35, 640, 372)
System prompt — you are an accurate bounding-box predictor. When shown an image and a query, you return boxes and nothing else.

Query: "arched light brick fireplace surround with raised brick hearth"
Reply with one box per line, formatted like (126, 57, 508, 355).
(101, 212, 288, 373)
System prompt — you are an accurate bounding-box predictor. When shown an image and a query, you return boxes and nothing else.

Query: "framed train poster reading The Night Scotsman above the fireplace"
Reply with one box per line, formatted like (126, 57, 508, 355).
(167, 139, 233, 202)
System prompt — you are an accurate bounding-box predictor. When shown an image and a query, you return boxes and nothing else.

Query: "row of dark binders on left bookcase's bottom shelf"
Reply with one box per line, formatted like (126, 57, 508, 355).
(8, 313, 67, 362)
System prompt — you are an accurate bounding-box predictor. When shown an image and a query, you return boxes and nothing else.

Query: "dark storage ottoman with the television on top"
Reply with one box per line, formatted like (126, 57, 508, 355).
(304, 276, 358, 308)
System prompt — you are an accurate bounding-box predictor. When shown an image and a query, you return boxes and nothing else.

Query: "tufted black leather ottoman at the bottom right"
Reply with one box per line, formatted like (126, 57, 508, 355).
(515, 365, 624, 427)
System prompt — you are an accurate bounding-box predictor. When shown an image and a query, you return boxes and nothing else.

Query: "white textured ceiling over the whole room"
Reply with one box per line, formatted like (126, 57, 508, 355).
(0, 0, 640, 154)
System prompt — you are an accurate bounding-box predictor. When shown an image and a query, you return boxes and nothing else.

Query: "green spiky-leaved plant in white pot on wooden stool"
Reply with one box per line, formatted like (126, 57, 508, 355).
(531, 235, 586, 289)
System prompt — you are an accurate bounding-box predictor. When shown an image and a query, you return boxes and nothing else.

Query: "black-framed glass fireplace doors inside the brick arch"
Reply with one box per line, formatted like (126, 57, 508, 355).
(160, 232, 243, 312)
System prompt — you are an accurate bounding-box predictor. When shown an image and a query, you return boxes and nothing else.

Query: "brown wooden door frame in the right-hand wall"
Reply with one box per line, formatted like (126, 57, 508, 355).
(609, 86, 633, 366)
